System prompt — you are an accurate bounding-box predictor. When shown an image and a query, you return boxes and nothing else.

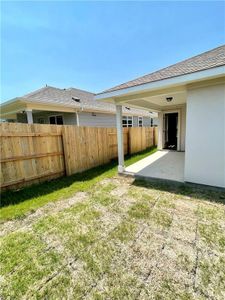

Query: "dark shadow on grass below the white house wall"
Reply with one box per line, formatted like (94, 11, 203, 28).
(133, 179, 225, 205)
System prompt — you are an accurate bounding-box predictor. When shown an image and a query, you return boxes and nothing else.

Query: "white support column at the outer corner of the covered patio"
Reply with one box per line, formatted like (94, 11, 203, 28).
(116, 105, 124, 173)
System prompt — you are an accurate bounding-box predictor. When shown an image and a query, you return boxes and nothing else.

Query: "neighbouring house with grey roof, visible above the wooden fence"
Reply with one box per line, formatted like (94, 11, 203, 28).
(1, 86, 157, 127)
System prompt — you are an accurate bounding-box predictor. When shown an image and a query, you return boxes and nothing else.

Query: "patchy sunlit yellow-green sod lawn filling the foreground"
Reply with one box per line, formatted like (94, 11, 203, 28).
(0, 148, 225, 300)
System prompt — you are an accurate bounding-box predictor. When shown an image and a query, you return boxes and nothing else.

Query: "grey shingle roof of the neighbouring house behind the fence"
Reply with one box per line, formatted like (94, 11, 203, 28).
(2, 86, 157, 117)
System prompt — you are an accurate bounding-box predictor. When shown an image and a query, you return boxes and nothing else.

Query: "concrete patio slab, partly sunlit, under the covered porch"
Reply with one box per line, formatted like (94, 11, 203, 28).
(125, 150, 184, 182)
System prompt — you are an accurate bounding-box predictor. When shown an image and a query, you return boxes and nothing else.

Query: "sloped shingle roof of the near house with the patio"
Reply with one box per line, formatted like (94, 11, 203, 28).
(99, 45, 225, 94)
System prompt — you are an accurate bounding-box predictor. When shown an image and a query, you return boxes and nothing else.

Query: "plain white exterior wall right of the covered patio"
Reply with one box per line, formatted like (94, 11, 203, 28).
(185, 84, 225, 187)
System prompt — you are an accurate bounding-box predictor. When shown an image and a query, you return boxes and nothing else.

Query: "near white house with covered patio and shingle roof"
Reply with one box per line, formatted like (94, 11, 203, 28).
(95, 45, 225, 188)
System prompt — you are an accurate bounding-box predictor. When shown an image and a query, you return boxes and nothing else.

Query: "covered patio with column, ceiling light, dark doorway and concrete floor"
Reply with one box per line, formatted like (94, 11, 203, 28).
(111, 88, 186, 182)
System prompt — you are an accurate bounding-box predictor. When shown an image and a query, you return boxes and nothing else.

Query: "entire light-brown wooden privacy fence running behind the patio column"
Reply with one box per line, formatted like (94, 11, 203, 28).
(0, 123, 155, 190)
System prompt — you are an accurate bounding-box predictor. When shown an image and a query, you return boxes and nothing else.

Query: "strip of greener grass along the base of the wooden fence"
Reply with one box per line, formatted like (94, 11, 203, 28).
(0, 147, 157, 222)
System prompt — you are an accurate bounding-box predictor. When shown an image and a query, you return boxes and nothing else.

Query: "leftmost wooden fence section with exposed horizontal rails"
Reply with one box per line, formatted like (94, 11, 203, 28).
(0, 123, 65, 188)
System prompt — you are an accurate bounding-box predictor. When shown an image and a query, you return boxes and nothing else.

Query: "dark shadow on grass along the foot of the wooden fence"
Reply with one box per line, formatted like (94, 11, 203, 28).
(0, 161, 117, 207)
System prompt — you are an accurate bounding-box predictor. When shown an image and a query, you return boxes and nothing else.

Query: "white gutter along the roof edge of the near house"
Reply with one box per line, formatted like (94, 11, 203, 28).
(94, 66, 225, 100)
